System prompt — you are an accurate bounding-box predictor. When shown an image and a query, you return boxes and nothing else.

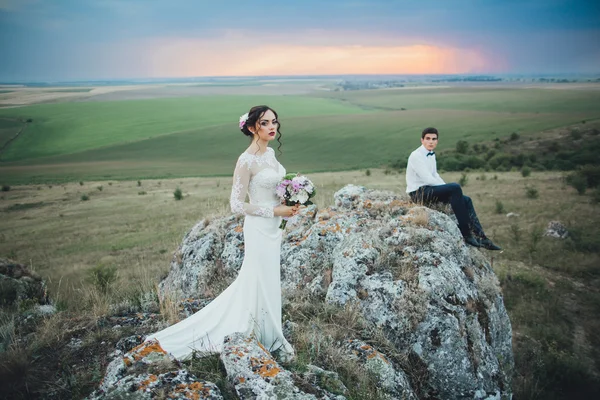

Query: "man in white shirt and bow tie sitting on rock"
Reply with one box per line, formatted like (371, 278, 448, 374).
(406, 128, 502, 250)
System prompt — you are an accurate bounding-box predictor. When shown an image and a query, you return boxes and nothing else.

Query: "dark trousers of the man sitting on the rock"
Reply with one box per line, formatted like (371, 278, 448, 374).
(409, 183, 486, 238)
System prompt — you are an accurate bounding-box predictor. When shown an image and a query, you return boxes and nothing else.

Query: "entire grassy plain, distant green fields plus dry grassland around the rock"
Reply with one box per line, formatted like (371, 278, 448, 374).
(0, 86, 600, 399)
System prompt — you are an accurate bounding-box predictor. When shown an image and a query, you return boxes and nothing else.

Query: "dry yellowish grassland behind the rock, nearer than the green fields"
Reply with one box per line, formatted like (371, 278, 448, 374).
(0, 170, 600, 399)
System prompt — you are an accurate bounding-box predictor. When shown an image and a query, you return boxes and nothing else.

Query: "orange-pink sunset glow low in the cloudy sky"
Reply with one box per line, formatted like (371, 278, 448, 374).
(145, 41, 494, 76)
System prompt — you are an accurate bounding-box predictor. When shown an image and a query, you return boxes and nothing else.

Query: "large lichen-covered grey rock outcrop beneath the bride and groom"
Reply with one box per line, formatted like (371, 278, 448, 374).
(96, 185, 513, 399)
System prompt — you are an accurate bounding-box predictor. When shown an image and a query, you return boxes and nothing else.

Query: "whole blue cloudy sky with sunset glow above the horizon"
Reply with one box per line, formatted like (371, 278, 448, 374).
(0, 0, 600, 82)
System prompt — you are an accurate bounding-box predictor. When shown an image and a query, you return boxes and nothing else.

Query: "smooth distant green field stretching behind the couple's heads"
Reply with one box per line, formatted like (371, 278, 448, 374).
(0, 87, 600, 184)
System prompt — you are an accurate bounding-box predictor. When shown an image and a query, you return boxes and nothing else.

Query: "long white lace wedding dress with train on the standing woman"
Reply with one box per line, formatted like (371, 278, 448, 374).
(146, 148, 294, 359)
